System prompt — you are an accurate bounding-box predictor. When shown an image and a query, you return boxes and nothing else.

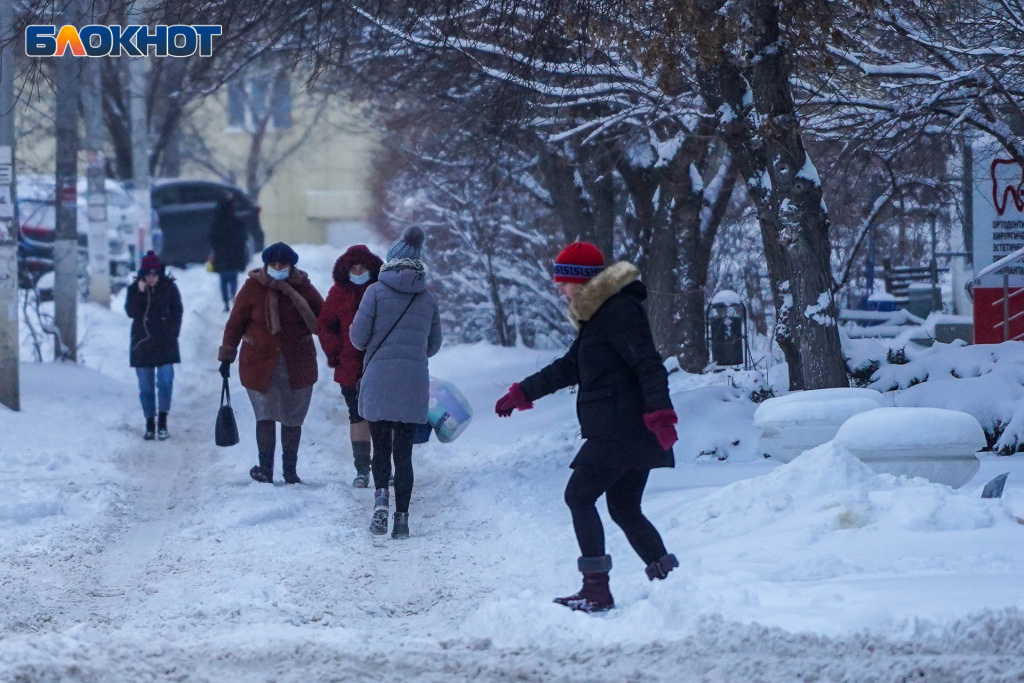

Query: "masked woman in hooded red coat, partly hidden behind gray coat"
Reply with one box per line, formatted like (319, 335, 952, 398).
(319, 245, 384, 488)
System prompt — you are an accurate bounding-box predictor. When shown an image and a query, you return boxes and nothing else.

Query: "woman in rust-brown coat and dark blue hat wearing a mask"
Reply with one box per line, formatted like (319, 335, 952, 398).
(217, 242, 324, 483)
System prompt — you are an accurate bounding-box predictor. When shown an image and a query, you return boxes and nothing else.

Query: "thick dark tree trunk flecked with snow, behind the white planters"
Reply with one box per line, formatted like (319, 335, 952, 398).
(698, 0, 848, 389)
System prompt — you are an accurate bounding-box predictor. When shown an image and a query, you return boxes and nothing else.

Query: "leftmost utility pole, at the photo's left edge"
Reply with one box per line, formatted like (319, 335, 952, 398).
(0, 0, 22, 411)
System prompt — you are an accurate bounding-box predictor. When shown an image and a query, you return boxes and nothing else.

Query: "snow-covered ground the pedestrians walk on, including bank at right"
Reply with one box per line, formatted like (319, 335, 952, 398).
(6, 248, 1024, 683)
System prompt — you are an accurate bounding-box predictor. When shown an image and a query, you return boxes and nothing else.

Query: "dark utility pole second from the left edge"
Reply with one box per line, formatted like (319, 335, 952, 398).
(53, 0, 83, 361)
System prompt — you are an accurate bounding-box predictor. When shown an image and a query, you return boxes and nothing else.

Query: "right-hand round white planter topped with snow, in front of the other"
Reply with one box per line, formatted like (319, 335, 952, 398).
(835, 408, 986, 488)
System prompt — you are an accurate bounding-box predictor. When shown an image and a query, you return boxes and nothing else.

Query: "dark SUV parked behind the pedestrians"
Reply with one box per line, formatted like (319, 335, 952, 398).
(153, 178, 263, 267)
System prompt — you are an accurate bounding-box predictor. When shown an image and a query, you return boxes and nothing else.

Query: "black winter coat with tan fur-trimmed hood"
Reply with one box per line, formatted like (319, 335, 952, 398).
(519, 262, 675, 469)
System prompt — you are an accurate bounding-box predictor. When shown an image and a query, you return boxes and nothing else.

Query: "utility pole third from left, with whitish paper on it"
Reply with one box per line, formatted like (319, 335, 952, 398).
(82, 59, 111, 308)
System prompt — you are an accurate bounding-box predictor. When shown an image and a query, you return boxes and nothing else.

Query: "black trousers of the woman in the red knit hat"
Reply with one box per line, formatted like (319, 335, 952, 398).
(565, 466, 667, 564)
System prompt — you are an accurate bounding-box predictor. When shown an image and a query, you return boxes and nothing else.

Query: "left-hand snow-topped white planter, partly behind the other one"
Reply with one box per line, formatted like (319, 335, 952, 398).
(754, 388, 882, 463)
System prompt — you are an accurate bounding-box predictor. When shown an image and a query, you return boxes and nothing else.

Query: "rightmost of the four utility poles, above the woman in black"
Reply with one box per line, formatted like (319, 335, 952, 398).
(128, 0, 153, 259)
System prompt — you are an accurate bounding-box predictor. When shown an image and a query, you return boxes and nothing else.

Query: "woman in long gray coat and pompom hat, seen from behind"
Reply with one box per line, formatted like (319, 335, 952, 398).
(348, 226, 441, 539)
